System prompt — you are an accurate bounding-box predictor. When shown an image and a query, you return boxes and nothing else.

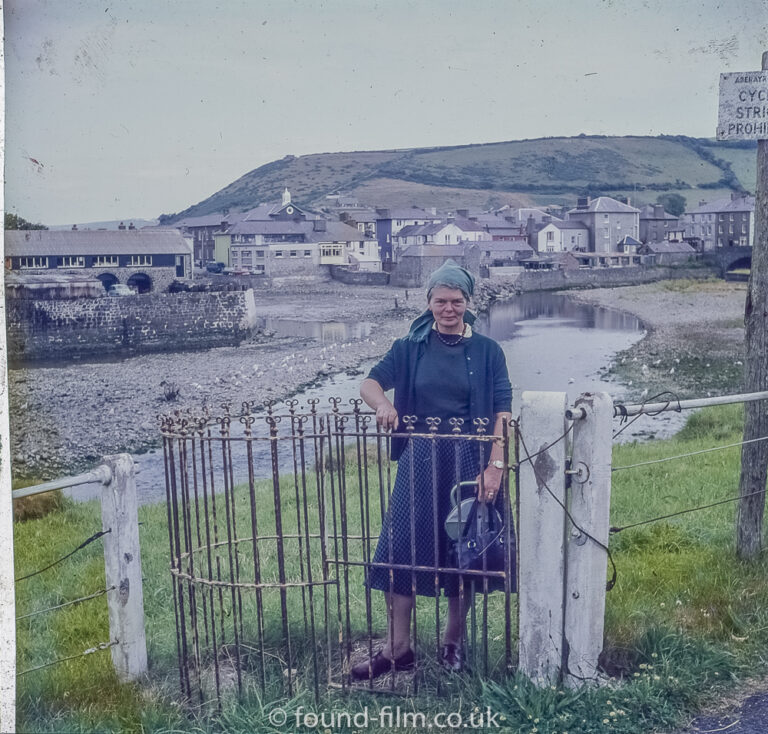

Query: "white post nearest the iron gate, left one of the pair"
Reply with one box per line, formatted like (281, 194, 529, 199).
(518, 392, 567, 684)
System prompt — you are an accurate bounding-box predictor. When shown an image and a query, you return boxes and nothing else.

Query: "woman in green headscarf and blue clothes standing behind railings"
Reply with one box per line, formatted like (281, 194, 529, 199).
(351, 260, 512, 680)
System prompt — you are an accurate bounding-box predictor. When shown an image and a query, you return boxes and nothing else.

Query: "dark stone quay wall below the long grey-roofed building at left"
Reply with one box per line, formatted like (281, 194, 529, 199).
(6, 290, 257, 364)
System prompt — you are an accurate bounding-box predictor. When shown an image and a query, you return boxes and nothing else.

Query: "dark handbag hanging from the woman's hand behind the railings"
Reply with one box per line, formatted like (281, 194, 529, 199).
(446, 486, 517, 591)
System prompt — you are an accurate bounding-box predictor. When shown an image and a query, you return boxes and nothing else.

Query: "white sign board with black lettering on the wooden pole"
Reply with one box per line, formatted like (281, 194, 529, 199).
(717, 71, 768, 140)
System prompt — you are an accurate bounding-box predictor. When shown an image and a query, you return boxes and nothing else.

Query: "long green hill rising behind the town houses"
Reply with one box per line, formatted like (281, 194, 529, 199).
(161, 135, 756, 223)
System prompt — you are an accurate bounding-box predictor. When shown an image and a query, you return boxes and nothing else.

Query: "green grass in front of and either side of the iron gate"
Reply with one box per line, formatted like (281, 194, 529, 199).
(15, 407, 768, 734)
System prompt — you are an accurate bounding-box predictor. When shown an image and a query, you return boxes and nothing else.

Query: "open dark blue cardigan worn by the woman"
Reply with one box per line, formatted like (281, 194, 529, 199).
(368, 331, 512, 459)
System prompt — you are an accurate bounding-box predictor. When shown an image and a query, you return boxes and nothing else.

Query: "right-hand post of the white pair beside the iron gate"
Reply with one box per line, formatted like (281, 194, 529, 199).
(563, 392, 613, 687)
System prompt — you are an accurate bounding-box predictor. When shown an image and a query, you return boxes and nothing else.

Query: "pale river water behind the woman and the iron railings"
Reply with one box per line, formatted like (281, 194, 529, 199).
(67, 293, 674, 504)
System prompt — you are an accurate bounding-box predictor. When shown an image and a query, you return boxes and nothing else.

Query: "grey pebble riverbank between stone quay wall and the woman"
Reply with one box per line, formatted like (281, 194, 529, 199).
(9, 283, 424, 480)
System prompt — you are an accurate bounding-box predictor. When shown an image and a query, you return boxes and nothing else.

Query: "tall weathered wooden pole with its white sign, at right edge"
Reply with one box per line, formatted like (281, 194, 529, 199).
(717, 51, 768, 559)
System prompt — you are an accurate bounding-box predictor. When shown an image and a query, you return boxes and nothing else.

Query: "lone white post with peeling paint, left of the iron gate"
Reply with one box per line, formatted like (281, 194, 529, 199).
(101, 454, 147, 681)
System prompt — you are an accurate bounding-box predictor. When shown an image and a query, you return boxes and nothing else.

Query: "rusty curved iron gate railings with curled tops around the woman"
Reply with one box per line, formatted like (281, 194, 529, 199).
(161, 398, 517, 703)
